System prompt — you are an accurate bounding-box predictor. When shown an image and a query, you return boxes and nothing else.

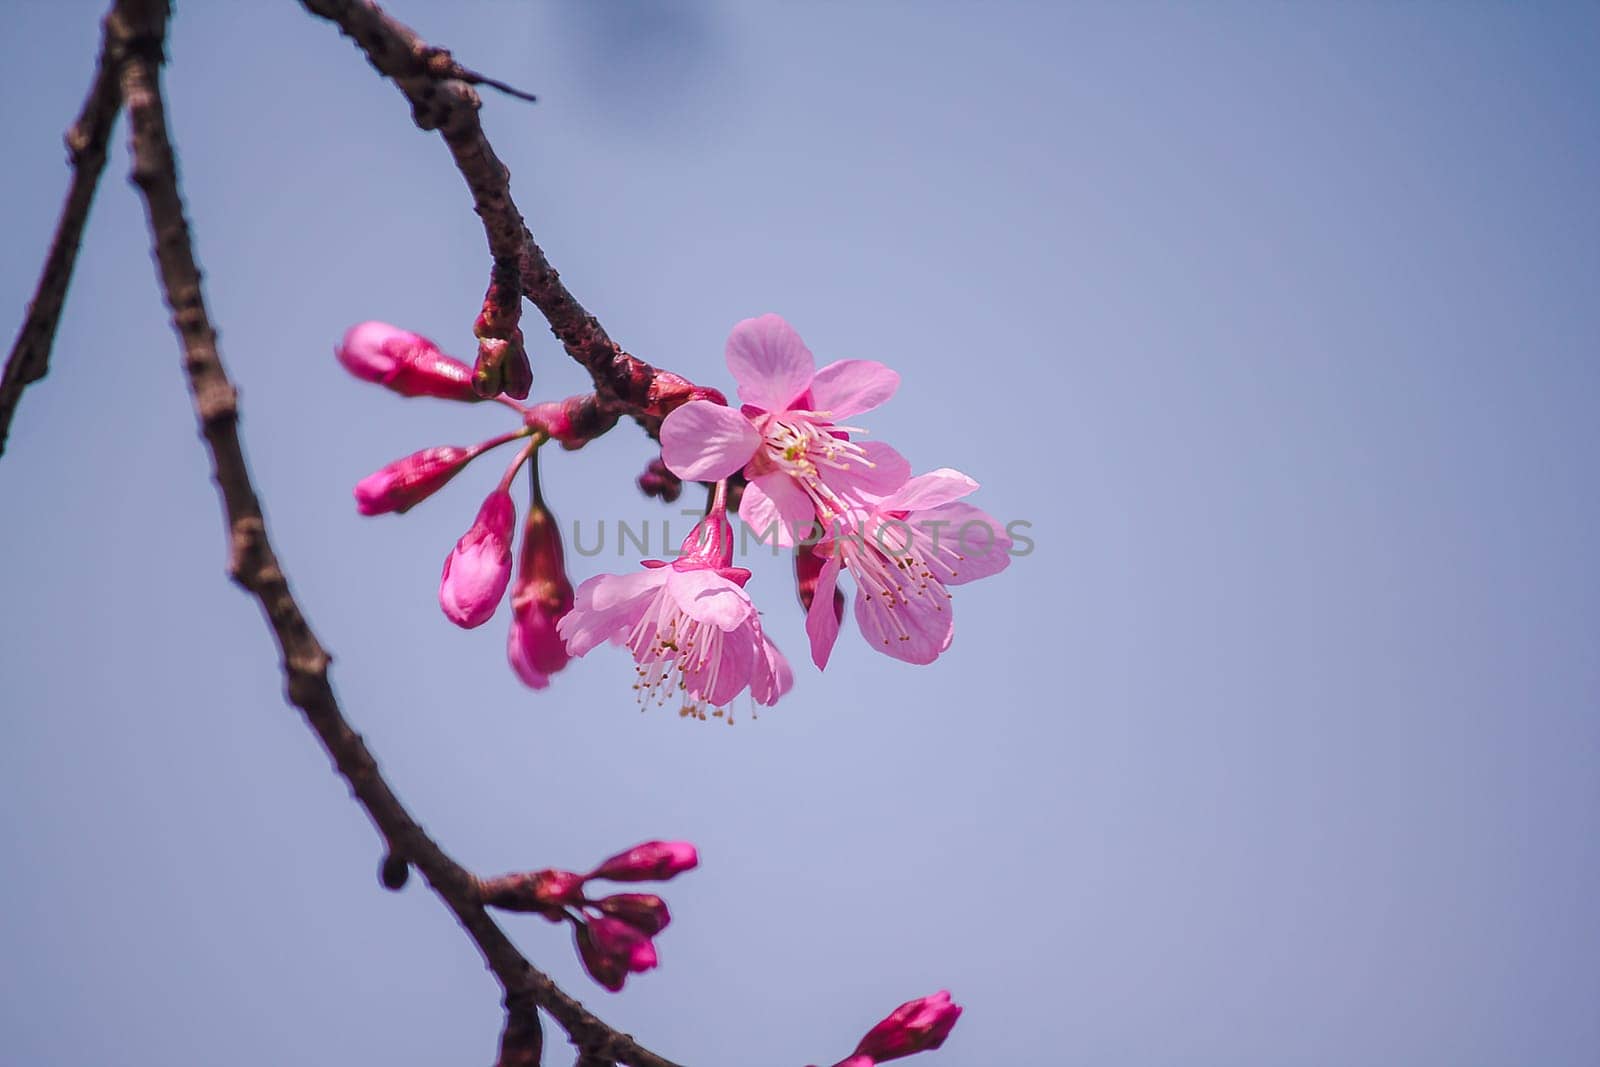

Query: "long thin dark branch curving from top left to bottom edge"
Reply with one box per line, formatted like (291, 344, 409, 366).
(118, 0, 675, 1067)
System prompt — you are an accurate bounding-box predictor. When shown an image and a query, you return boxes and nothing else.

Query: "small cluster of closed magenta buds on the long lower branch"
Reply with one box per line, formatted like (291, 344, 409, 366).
(480, 841, 699, 993)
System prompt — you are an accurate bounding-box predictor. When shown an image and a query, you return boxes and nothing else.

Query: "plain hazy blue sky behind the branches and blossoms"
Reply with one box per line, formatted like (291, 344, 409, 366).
(0, 0, 1600, 1067)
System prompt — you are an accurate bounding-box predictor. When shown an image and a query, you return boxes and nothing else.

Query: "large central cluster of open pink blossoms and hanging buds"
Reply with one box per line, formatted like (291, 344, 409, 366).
(338, 315, 1011, 721)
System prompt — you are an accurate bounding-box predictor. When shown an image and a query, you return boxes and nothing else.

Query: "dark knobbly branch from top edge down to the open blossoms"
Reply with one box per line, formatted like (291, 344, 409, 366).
(301, 0, 723, 422)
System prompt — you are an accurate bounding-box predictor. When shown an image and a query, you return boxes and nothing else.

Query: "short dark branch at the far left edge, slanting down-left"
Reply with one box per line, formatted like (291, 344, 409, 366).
(0, 3, 130, 454)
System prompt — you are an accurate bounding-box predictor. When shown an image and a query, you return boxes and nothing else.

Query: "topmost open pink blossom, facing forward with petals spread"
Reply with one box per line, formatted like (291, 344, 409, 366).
(661, 315, 910, 544)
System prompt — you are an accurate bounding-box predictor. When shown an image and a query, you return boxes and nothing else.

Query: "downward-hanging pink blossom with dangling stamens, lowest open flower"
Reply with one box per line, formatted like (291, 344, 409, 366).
(557, 485, 794, 710)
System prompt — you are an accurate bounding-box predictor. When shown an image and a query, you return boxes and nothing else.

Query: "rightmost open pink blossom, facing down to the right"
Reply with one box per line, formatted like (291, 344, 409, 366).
(805, 469, 1011, 669)
